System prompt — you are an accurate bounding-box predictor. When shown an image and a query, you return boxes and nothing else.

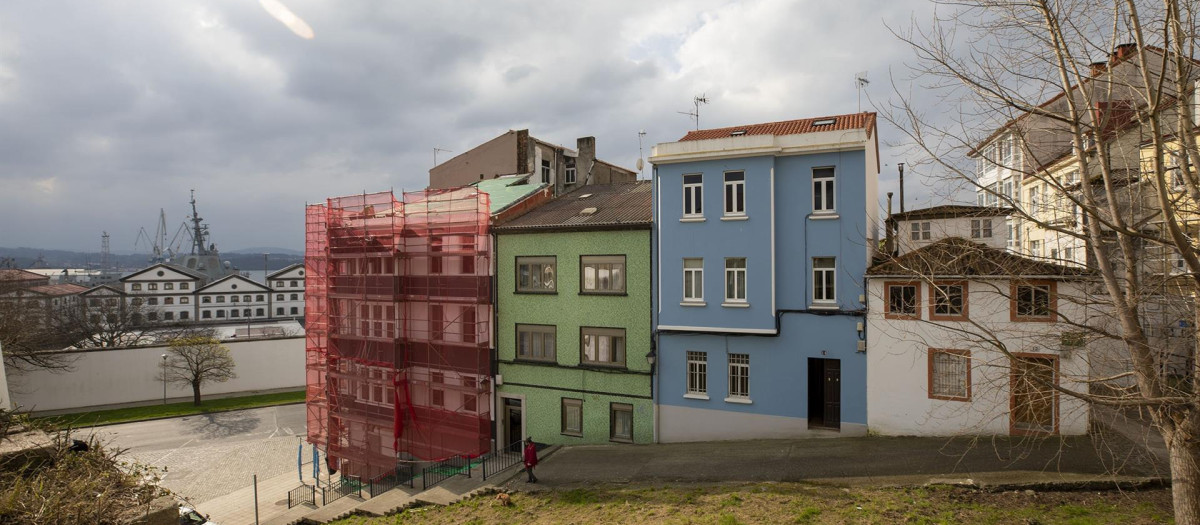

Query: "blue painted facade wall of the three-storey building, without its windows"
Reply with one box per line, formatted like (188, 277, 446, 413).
(654, 145, 875, 441)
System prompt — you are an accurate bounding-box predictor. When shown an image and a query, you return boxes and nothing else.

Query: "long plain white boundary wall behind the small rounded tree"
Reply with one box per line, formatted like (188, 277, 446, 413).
(7, 337, 305, 412)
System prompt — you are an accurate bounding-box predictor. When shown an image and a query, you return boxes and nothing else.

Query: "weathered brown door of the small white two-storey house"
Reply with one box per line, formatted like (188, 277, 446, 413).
(1009, 357, 1057, 434)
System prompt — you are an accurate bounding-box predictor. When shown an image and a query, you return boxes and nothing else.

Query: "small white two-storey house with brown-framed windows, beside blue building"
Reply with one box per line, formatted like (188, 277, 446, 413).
(866, 239, 1116, 435)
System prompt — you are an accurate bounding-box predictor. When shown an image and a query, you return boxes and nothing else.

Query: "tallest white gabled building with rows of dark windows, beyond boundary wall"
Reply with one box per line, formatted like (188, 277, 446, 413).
(121, 263, 204, 322)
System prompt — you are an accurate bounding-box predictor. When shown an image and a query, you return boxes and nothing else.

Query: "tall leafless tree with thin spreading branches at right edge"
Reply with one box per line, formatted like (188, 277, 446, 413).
(881, 0, 1200, 517)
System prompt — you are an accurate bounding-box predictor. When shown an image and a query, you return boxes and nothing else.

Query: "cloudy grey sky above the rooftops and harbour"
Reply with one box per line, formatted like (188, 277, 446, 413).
(0, 0, 931, 253)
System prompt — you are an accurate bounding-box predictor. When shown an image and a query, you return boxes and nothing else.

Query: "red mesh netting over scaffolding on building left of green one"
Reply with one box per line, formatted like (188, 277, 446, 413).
(305, 187, 492, 478)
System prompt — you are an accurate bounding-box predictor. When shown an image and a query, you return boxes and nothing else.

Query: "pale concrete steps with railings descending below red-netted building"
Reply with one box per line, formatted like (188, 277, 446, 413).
(276, 446, 559, 525)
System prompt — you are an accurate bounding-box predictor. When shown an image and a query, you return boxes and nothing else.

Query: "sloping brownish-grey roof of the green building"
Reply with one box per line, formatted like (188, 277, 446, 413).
(496, 181, 654, 231)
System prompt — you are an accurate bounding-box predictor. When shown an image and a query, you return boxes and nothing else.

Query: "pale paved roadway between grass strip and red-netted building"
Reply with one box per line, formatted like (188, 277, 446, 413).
(95, 404, 311, 502)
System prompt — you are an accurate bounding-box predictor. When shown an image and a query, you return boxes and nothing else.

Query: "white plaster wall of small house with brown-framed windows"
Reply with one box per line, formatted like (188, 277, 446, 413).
(866, 277, 1116, 435)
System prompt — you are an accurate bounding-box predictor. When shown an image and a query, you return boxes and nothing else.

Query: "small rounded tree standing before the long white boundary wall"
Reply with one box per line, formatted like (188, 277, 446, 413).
(160, 334, 238, 406)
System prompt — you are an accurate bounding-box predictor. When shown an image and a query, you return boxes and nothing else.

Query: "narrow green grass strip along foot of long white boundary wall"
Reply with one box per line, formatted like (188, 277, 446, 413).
(36, 391, 304, 428)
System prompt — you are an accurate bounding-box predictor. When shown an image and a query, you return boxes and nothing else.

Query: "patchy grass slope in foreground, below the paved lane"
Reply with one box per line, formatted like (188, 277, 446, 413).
(335, 483, 1171, 525)
